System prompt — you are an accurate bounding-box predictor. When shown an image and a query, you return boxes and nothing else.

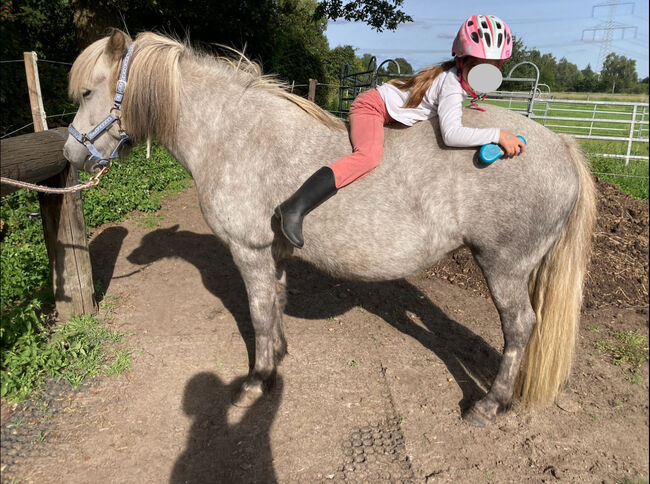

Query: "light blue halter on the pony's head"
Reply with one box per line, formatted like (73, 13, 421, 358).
(68, 43, 135, 167)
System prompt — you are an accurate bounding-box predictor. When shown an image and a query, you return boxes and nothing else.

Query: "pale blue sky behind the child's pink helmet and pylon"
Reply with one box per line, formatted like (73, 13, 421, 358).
(325, 0, 648, 78)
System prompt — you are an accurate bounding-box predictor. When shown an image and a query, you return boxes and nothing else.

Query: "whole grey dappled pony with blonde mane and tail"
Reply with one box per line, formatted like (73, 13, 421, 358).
(64, 31, 595, 425)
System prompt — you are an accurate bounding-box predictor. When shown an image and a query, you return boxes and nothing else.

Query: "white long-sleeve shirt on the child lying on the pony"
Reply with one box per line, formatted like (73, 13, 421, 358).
(377, 67, 500, 147)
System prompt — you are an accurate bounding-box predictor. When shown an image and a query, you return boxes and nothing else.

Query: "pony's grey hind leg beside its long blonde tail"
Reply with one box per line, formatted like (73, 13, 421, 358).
(463, 258, 536, 427)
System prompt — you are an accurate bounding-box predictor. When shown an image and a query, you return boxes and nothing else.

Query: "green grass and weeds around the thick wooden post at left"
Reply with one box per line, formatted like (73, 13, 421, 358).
(0, 142, 190, 401)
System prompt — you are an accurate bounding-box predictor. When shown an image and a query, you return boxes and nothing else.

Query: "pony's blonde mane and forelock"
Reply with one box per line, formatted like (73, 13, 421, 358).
(68, 32, 345, 144)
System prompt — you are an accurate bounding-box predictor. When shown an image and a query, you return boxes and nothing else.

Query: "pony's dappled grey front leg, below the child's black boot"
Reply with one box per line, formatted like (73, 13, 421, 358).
(231, 246, 286, 407)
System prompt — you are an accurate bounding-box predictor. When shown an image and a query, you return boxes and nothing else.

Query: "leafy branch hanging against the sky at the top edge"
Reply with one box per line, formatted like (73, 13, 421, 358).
(315, 0, 413, 32)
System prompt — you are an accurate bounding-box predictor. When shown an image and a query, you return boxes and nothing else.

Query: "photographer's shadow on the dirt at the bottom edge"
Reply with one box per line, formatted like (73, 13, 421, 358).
(169, 372, 283, 484)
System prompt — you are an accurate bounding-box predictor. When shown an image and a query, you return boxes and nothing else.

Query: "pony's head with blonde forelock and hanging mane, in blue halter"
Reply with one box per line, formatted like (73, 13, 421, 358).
(63, 30, 185, 172)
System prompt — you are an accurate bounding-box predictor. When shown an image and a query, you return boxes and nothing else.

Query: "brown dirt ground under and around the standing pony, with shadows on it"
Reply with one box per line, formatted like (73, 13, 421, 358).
(2, 184, 648, 483)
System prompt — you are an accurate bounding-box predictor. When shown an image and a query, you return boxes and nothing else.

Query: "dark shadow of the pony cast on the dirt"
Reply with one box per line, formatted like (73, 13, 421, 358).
(116, 226, 501, 411)
